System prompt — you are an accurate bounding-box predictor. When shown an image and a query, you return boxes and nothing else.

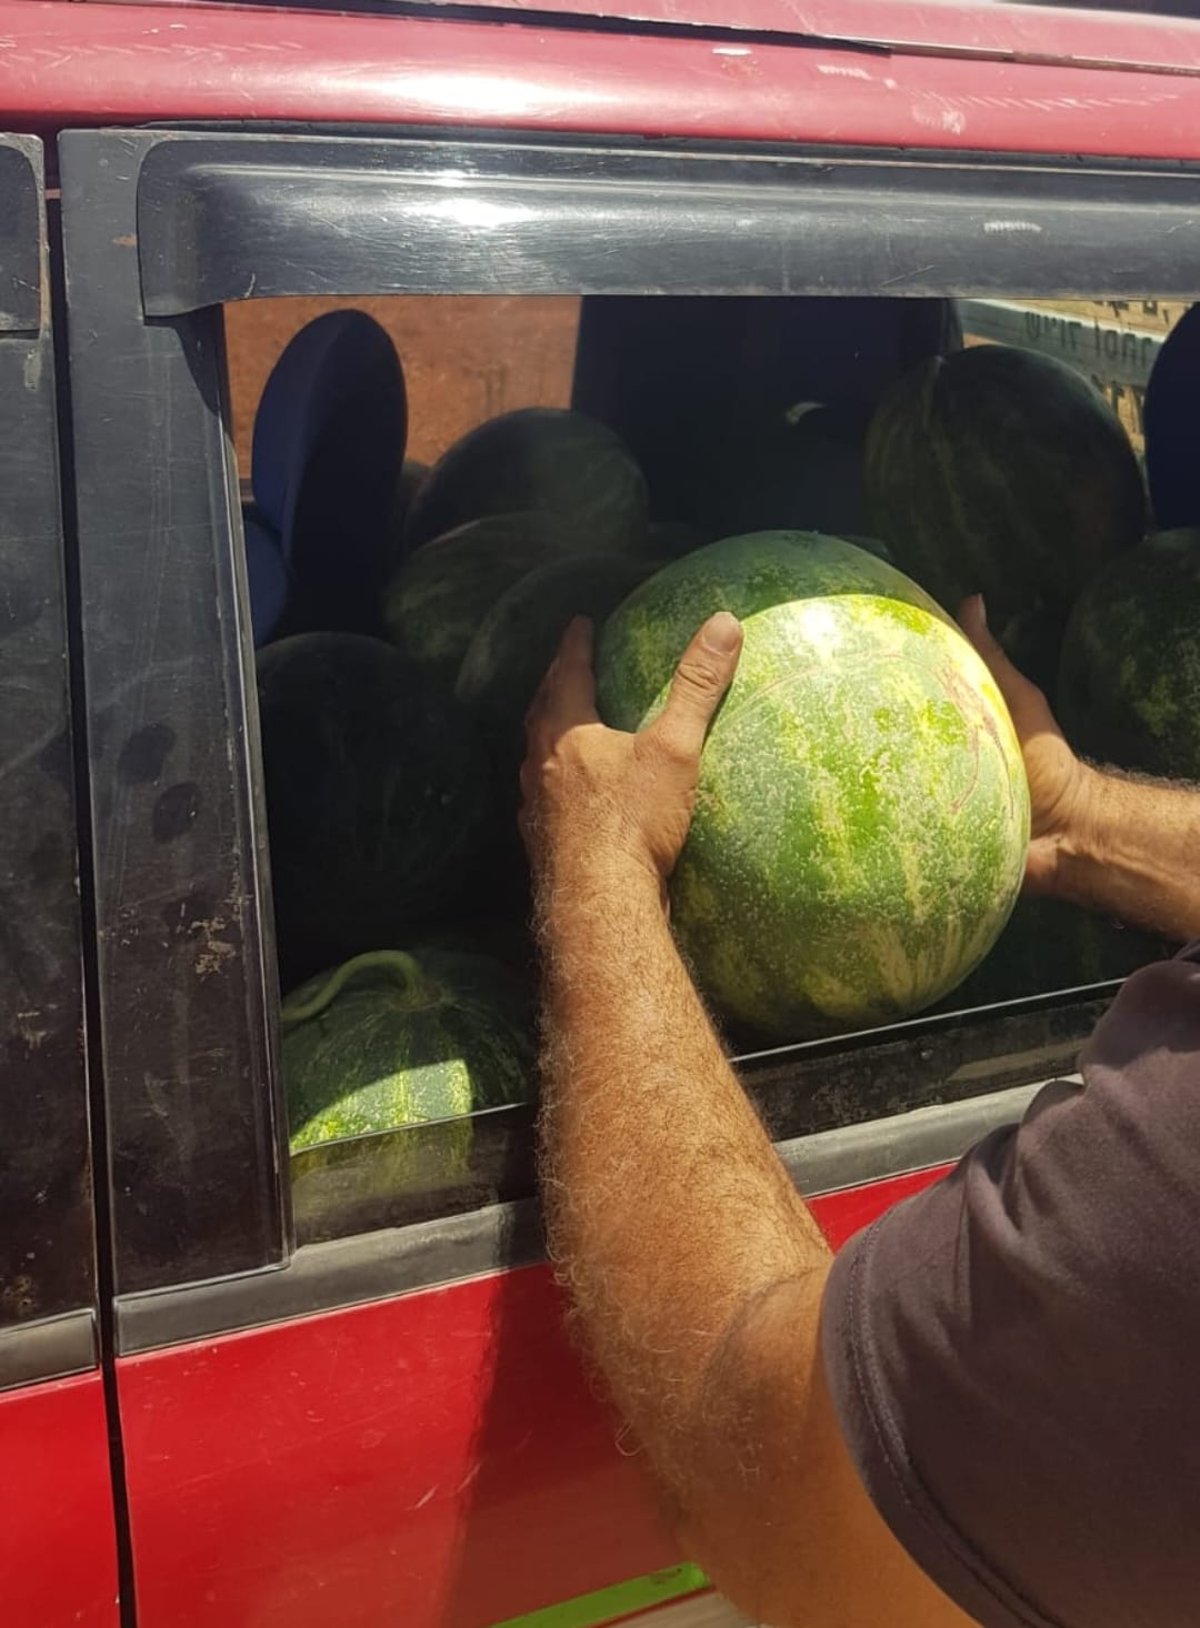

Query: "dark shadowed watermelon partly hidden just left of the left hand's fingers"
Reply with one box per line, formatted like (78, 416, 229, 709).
(456, 554, 653, 798)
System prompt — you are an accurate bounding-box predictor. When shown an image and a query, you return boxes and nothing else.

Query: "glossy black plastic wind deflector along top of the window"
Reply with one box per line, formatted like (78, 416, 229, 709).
(137, 132, 1200, 316)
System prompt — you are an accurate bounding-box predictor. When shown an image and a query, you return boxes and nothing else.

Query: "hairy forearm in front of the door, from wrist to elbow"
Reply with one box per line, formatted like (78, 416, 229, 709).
(541, 868, 827, 1514)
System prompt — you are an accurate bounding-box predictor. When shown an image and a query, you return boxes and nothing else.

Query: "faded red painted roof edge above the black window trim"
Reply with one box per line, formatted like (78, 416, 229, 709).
(0, 0, 1200, 158)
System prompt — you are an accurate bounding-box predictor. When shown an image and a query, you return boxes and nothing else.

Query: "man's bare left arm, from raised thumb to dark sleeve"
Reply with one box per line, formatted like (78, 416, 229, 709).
(523, 617, 969, 1628)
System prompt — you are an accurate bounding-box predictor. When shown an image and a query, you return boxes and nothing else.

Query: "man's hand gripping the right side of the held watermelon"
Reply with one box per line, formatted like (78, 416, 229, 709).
(959, 594, 1099, 894)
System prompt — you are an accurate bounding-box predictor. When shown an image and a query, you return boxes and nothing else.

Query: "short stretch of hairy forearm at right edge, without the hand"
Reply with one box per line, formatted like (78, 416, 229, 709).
(1055, 770, 1200, 943)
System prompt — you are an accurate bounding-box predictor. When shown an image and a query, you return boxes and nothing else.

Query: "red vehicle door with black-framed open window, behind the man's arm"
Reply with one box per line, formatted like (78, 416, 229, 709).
(60, 73, 1200, 1628)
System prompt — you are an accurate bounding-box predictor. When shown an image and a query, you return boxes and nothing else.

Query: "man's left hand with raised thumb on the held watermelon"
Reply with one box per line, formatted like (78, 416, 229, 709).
(521, 611, 742, 887)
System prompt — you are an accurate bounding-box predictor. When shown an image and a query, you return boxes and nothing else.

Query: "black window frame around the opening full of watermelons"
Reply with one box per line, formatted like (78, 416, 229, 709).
(60, 129, 1200, 1350)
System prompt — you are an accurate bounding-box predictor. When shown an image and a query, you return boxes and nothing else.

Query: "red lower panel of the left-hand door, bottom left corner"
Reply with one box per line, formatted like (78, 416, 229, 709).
(0, 1374, 119, 1628)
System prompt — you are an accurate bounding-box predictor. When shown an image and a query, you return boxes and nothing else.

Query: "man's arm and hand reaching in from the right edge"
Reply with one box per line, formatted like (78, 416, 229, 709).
(959, 597, 1200, 943)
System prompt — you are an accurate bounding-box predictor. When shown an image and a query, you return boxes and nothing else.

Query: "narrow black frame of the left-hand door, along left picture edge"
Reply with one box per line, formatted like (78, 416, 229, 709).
(0, 135, 98, 1389)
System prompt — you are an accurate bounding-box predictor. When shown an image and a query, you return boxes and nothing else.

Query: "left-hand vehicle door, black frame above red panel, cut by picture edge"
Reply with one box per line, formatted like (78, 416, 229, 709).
(0, 135, 119, 1628)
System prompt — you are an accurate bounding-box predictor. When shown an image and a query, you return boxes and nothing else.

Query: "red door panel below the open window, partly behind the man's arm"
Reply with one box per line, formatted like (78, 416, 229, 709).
(117, 1172, 936, 1628)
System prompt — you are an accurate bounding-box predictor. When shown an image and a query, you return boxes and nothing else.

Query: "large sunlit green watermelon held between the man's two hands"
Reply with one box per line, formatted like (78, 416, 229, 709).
(598, 532, 1029, 1039)
